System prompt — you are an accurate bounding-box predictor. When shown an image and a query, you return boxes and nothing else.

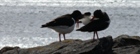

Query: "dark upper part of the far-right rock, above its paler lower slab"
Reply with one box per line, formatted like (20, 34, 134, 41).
(113, 35, 140, 48)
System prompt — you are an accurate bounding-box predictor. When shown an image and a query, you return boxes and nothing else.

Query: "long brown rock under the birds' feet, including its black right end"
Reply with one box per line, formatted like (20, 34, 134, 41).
(3, 36, 113, 54)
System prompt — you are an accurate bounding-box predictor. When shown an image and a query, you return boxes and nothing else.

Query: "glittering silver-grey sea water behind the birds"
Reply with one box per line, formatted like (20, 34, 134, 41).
(0, 0, 140, 48)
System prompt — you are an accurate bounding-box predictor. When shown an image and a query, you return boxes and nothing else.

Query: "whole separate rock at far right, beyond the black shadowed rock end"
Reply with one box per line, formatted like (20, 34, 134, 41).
(112, 35, 140, 54)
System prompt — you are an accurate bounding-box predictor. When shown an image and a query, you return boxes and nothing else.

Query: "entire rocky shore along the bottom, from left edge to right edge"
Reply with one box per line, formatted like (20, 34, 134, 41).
(0, 35, 140, 54)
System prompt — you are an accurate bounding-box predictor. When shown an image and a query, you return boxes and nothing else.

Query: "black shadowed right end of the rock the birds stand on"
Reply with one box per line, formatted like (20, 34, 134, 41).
(80, 36, 113, 54)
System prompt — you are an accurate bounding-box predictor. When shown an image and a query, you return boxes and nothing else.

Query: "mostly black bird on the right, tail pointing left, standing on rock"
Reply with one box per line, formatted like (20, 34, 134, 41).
(77, 10, 110, 39)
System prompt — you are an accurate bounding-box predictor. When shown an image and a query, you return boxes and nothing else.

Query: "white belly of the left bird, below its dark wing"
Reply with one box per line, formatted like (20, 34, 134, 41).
(51, 25, 75, 34)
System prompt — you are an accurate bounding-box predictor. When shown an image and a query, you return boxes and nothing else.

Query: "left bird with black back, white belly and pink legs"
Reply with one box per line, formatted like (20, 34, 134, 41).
(41, 10, 83, 42)
